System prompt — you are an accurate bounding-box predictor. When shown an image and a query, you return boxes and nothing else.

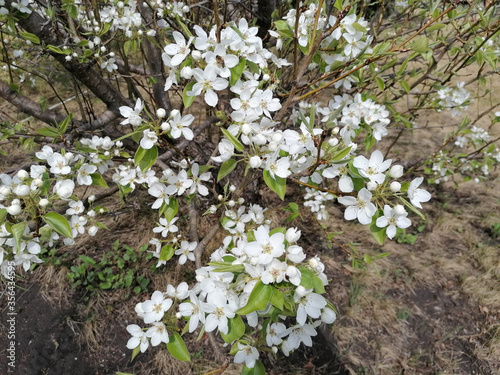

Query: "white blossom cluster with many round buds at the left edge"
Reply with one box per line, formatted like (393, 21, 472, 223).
(0, 136, 123, 275)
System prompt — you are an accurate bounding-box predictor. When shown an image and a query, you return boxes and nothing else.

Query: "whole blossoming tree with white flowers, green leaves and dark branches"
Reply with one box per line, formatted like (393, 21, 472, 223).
(0, 0, 500, 374)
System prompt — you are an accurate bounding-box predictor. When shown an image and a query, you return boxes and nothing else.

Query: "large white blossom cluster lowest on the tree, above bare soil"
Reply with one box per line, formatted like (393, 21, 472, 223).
(127, 220, 336, 368)
